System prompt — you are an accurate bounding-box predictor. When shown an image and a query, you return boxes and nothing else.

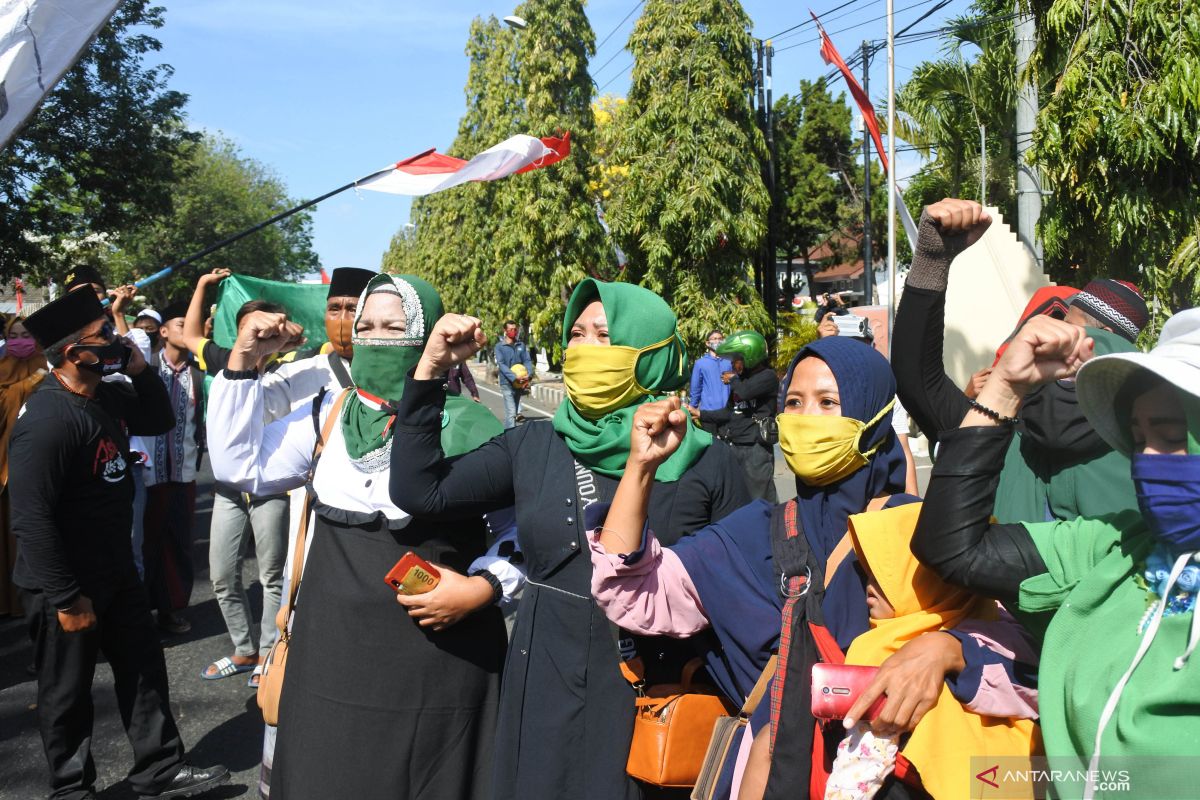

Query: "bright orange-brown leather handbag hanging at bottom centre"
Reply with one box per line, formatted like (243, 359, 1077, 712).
(622, 658, 730, 787)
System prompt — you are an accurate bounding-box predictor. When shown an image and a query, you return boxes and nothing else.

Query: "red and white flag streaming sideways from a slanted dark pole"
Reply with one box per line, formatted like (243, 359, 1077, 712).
(355, 132, 571, 196)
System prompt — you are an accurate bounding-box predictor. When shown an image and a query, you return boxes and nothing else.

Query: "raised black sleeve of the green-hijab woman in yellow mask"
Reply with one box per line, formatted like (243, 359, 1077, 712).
(390, 373, 514, 519)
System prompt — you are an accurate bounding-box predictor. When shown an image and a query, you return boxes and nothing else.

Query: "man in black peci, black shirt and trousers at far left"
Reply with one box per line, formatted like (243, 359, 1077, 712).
(8, 288, 229, 800)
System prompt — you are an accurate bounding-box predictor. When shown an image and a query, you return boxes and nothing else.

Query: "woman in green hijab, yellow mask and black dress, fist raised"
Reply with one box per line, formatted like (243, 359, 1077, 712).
(391, 279, 749, 800)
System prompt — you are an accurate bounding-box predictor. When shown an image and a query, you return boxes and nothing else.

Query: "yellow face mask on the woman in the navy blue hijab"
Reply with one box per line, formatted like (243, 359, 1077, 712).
(775, 398, 895, 486)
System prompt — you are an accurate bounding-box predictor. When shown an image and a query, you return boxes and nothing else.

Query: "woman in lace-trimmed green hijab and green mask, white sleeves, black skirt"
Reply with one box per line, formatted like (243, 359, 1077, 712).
(209, 275, 505, 800)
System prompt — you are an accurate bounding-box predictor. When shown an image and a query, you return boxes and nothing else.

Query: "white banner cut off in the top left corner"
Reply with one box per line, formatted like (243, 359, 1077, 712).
(0, 0, 119, 149)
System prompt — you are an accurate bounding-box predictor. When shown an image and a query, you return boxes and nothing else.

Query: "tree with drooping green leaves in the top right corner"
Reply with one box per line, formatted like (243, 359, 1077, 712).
(1032, 0, 1200, 308)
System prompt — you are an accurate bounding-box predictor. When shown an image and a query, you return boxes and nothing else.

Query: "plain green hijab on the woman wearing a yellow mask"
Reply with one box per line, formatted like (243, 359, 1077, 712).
(554, 278, 713, 483)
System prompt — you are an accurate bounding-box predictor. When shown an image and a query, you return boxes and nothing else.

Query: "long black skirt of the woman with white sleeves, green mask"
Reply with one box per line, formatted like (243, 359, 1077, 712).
(271, 505, 504, 800)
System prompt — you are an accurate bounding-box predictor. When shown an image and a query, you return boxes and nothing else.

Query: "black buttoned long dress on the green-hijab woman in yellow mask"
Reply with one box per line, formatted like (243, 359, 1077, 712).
(391, 378, 749, 800)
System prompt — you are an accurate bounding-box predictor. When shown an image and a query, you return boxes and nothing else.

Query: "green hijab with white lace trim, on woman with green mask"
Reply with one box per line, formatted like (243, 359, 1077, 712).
(342, 273, 504, 473)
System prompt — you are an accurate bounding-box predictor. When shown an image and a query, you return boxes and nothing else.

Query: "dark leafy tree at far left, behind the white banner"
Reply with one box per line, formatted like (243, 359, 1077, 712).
(0, 0, 194, 284)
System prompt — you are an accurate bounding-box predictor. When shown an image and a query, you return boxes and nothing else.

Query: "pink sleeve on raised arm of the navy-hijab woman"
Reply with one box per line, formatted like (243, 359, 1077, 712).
(586, 503, 708, 638)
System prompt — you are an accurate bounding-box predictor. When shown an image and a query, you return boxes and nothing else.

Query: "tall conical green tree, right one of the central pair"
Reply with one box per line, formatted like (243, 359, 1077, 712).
(607, 0, 775, 351)
